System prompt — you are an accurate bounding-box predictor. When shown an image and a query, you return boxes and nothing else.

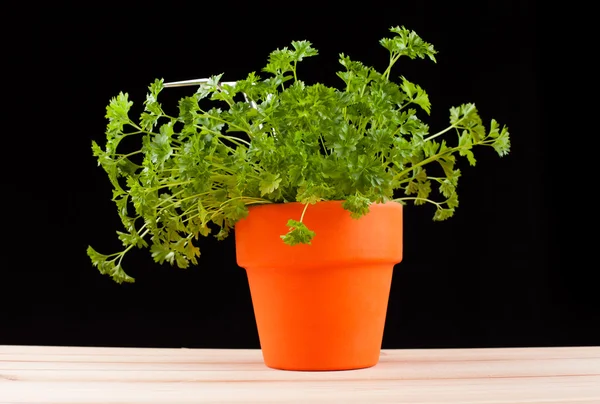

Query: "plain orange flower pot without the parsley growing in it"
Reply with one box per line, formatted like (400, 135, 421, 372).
(235, 201, 402, 371)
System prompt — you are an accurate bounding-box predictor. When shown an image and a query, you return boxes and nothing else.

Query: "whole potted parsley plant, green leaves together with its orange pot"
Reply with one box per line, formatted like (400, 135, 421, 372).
(87, 27, 510, 370)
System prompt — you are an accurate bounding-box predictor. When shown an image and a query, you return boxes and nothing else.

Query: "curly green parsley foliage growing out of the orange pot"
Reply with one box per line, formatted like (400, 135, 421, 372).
(87, 27, 510, 283)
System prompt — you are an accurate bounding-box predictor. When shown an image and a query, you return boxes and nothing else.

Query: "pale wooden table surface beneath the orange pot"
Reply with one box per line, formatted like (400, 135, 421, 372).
(0, 346, 600, 404)
